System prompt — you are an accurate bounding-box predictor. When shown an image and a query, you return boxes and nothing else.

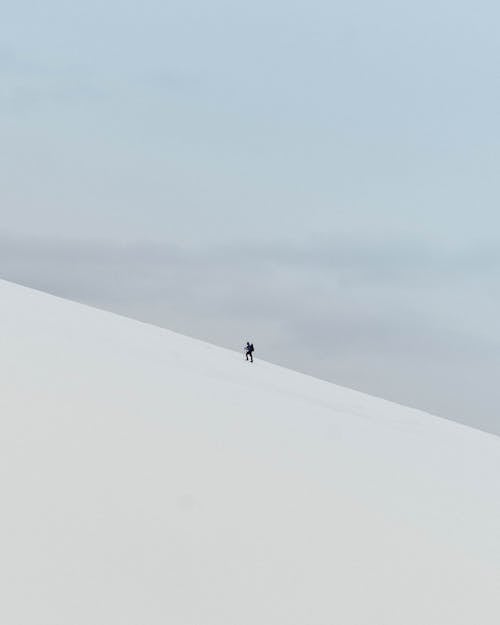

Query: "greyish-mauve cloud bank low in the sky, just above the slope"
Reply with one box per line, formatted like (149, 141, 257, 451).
(0, 236, 500, 433)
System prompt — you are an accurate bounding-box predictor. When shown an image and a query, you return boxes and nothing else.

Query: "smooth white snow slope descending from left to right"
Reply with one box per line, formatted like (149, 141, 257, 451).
(0, 281, 500, 625)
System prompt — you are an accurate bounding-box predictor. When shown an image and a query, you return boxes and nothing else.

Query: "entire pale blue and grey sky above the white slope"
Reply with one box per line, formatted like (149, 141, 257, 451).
(0, 0, 500, 433)
